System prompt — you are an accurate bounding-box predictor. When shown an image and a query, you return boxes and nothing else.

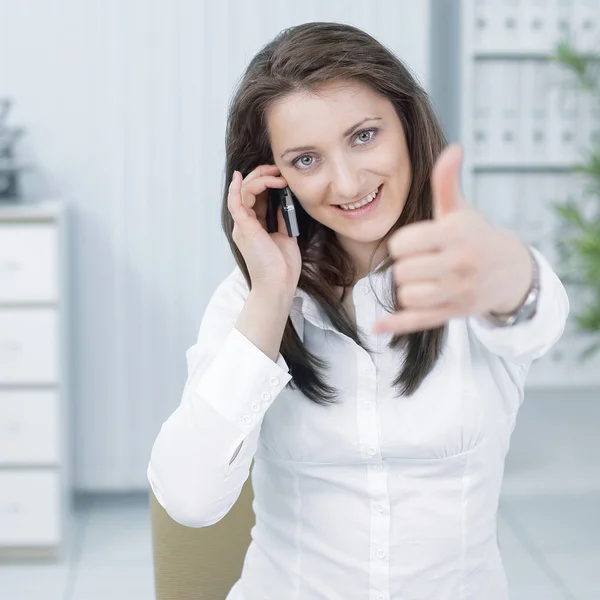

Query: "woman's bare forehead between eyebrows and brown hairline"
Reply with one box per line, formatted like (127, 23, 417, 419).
(267, 82, 393, 143)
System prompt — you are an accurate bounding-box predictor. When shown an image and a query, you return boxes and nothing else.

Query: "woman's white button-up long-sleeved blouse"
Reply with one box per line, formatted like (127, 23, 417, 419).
(148, 248, 569, 600)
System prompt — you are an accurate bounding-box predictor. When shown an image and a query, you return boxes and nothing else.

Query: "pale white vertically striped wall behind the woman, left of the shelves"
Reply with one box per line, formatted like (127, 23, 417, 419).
(0, 0, 430, 490)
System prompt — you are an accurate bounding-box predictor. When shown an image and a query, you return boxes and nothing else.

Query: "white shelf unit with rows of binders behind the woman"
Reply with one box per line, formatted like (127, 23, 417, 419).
(461, 0, 600, 389)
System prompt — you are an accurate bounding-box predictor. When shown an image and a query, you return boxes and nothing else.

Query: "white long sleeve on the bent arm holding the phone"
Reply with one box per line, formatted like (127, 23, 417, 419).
(147, 269, 291, 527)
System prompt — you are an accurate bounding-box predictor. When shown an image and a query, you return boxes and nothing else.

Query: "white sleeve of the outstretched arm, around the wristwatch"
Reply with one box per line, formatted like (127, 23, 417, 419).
(468, 247, 570, 365)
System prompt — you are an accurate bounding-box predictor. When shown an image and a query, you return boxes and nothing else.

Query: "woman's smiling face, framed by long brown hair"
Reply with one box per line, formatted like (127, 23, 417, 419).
(267, 82, 411, 271)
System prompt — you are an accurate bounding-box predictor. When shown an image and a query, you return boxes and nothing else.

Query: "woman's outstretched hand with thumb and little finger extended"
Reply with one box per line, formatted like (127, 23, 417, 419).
(373, 146, 533, 334)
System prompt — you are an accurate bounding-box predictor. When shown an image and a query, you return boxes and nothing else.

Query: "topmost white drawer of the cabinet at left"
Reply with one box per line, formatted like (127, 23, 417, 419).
(0, 224, 58, 302)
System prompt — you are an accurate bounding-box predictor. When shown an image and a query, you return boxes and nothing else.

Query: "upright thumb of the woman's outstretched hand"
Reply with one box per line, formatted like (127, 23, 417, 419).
(431, 144, 464, 219)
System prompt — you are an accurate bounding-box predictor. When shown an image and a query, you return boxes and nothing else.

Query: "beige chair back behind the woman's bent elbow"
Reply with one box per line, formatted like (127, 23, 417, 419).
(150, 479, 254, 600)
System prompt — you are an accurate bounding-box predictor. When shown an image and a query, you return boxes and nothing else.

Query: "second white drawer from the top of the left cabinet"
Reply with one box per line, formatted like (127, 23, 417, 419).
(0, 308, 59, 384)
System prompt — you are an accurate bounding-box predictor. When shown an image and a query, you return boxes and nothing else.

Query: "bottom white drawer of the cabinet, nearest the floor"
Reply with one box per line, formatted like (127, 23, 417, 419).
(0, 470, 61, 546)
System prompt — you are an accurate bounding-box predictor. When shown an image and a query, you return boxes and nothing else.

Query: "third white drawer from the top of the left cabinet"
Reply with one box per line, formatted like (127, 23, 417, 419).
(0, 390, 60, 465)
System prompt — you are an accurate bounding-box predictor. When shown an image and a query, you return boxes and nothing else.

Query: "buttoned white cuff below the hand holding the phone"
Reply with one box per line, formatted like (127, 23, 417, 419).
(191, 327, 292, 431)
